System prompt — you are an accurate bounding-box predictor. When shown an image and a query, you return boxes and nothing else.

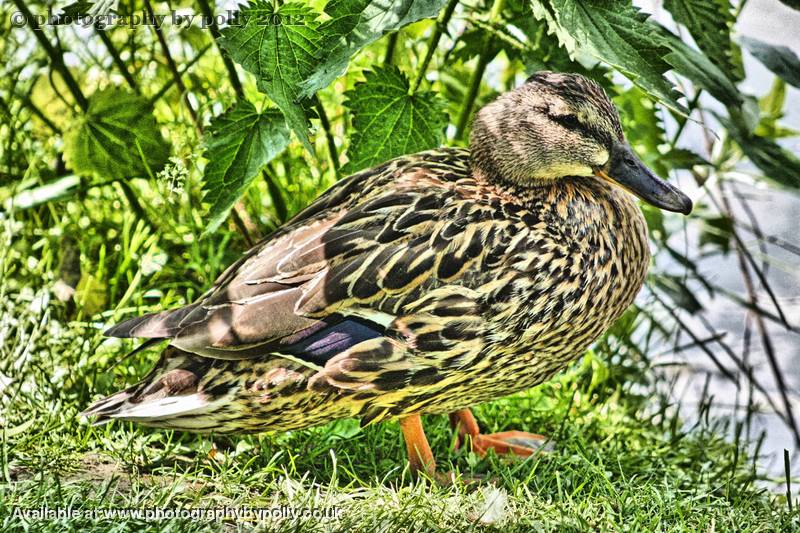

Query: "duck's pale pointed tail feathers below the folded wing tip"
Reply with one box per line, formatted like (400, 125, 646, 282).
(81, 346, 216, 432)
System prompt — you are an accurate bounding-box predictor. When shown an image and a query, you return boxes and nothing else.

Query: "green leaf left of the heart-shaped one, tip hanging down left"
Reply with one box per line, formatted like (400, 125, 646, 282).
(203, 101, 289, 234)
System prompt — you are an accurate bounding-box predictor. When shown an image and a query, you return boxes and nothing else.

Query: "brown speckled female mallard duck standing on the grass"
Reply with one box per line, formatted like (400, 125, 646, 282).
(85, 72, 692, 475)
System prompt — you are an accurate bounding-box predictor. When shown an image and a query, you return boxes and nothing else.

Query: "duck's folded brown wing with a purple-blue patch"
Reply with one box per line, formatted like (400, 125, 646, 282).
(107, 150, 498, 374)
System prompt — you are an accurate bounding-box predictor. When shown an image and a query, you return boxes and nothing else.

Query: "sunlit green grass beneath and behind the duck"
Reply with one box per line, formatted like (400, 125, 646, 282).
(0, 180, 800, 531)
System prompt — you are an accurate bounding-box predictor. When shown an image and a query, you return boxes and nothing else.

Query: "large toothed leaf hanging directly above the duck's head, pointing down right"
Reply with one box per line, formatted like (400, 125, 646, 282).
(532, 0, 687, 113)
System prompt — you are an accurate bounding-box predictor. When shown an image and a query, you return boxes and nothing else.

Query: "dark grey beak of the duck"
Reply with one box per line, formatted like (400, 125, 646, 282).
(595, 142, 692, 215)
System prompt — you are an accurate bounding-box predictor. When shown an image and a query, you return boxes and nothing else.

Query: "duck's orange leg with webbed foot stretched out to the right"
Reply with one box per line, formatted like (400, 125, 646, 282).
(450, 409, 547, 457)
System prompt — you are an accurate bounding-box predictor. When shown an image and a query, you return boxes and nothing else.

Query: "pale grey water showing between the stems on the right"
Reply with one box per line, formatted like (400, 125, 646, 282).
(639, 0, 800, 478)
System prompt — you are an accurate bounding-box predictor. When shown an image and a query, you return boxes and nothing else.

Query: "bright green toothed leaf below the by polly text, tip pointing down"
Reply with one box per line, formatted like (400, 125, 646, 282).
(219, 0, 321, 150)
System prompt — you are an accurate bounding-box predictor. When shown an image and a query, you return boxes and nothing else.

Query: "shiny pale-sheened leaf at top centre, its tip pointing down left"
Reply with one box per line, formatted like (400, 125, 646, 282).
(301, 0, 446, 97)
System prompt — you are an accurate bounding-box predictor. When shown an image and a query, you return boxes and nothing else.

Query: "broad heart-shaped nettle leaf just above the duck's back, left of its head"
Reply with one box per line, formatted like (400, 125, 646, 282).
(342, 66, 448, 173)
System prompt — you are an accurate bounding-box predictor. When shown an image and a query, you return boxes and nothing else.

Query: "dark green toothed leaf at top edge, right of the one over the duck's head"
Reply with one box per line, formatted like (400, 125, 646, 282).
(664, 0, 744, 80)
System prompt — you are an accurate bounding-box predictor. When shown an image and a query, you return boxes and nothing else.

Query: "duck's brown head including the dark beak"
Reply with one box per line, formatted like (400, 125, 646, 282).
(470, 72, 692, 215)
